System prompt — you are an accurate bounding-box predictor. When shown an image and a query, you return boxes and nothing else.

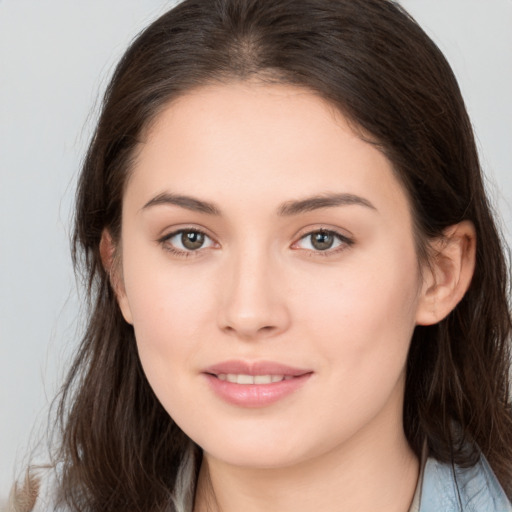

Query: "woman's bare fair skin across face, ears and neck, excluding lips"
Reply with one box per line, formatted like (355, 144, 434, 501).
(107, 83, 474, 512)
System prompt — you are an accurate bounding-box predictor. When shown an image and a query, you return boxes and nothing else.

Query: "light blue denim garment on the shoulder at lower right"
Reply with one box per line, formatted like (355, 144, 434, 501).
(420, 456, 512, 512)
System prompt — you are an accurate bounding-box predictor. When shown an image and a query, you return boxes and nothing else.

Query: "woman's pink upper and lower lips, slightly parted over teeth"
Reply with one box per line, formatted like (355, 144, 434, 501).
(203, 361, 313, 407)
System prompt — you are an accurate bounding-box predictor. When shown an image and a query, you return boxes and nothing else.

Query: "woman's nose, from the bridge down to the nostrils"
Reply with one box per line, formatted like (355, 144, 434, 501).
(219, 245, 290, 340)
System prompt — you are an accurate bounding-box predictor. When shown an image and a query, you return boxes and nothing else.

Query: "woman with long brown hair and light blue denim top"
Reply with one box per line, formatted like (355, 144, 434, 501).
(10, 0, 512, 512)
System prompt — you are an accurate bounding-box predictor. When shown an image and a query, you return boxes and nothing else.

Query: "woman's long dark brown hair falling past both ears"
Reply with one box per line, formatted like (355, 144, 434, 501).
(38, 0, 512, 512)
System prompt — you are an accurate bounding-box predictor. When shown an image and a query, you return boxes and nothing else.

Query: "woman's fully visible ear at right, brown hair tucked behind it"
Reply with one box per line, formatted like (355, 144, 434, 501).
(416, 221, 476, 325)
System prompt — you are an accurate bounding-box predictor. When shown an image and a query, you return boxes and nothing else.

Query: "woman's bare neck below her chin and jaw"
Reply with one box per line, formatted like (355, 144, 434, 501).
(194, 425, 419, 512)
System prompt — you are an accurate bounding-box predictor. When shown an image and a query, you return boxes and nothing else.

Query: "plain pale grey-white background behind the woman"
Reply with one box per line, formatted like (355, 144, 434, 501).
(0, 0, 512, 502)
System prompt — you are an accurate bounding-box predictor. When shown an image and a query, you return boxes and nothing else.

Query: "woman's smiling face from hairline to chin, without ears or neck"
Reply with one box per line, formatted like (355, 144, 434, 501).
(118, 83, 428, 467)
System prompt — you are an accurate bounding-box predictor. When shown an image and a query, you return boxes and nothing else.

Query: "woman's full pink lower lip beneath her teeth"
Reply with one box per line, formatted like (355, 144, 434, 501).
(204, 373, 312, 407)
